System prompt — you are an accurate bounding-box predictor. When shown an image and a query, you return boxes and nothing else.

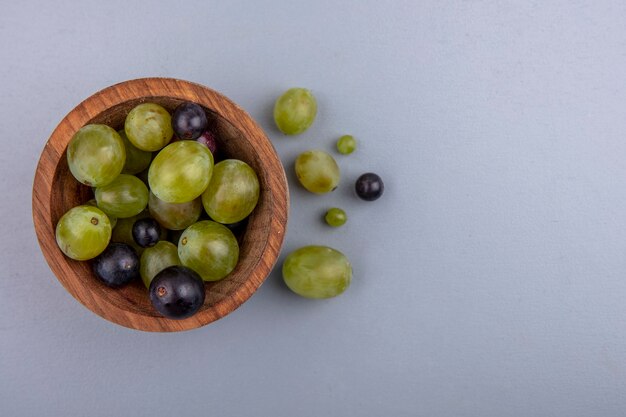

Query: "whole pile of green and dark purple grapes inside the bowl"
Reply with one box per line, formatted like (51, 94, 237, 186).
(56, 103, 260, 319)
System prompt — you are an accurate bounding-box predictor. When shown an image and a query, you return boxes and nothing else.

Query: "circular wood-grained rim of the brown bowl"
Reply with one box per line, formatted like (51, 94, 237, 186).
(32, 77, 289, 332)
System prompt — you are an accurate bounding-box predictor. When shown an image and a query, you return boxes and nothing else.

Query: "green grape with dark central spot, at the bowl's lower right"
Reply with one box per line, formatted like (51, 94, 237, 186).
(178, 220, 239, 281)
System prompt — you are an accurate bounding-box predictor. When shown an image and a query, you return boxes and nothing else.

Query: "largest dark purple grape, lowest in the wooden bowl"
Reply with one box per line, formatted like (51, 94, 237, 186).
(149, 265, 204, 320)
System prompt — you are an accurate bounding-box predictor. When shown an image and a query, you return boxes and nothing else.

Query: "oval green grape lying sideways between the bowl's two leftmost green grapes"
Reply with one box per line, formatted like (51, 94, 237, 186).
(96, 174, 148, 218)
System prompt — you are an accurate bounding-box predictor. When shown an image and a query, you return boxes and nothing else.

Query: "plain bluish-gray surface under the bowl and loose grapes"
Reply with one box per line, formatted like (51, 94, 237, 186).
(0, 0, 626, 417)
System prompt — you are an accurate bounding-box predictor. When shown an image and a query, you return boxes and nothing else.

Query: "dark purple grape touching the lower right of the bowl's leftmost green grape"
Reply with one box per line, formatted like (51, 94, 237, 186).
(93, 243, 139, 287)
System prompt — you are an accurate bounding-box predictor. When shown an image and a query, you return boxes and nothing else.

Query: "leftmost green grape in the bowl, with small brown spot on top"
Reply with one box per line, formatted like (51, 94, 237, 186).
(56, 205, 111, 261)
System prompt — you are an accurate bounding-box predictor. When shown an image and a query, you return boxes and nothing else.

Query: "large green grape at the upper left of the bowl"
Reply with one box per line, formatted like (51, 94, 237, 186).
(67, 124, 126, 187)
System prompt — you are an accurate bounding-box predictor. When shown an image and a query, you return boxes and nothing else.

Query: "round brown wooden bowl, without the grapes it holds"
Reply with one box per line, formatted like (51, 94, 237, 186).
(32, 78, 289, 332)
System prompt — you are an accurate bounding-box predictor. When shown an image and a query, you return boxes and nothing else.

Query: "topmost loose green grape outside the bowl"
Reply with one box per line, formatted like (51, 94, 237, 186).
(274, 88, 317, 135)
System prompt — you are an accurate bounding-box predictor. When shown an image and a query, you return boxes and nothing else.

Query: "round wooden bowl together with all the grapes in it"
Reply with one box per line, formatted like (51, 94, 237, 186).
(33, 78, 288, 331)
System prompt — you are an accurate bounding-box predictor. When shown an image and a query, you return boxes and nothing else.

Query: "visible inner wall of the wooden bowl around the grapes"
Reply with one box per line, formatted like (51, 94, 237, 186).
(49, 96, 270, 321)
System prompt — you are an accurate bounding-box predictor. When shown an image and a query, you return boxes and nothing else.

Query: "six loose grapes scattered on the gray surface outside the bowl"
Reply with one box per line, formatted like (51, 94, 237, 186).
(274, 88, 384, 298)
